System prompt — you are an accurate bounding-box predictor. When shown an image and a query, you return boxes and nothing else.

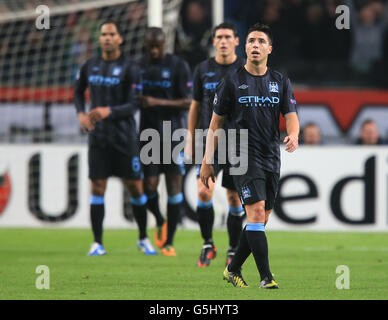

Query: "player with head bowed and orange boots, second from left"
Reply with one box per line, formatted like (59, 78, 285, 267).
(139, 27, 192, 256)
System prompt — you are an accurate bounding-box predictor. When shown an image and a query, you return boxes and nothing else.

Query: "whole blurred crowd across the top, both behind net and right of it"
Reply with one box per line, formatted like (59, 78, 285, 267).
(0, 0, 388, 88)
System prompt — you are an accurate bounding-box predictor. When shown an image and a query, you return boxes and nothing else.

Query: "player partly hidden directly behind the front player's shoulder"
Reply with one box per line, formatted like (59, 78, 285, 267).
(186, 23, 244, 267)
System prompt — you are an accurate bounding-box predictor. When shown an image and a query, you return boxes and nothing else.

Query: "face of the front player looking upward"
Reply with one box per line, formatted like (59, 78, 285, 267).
(245, 31, 272, 64)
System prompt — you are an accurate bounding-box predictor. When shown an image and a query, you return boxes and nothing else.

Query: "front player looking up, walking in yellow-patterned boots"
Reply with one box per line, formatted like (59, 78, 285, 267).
(200, 24, 299, 289)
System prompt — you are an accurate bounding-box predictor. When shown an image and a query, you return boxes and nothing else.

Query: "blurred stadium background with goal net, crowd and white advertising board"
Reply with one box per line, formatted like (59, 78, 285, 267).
(0, 0, 388, 230)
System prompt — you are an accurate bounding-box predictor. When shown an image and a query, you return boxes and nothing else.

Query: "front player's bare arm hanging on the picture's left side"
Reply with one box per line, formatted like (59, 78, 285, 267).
(200, 112, 225, 189)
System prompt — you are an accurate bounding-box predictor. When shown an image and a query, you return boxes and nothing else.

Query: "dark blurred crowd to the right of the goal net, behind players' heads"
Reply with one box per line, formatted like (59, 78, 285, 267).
(176, 0, 388, 87)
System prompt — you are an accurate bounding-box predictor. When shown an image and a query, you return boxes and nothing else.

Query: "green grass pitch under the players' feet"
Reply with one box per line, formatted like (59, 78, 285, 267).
(0, 228, 388, 300)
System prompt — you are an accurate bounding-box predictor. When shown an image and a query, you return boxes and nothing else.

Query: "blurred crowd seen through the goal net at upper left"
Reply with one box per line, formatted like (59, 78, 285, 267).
(0, 0, 147, 87)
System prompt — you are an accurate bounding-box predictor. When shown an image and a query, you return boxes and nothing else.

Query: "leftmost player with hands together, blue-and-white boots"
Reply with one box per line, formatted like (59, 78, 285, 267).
(74, 21, 156, 256)
